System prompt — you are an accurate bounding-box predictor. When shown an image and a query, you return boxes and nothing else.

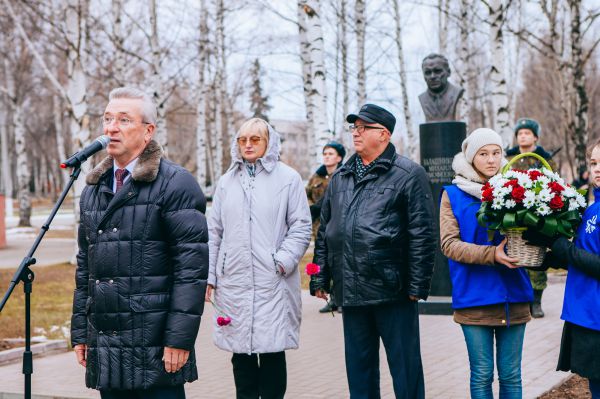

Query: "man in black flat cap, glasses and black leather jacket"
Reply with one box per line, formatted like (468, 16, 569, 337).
(310, 104, 436, 399)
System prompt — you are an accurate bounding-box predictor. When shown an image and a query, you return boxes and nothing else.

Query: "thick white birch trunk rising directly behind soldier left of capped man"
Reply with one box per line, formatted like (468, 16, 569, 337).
(302, 0, 331, 168)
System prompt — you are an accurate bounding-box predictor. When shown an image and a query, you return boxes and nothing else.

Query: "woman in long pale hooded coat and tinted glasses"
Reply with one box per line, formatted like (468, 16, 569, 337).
(206, 118, 311, 399)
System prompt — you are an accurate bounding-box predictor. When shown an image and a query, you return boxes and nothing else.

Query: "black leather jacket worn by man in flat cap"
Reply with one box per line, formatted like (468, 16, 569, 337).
(311, 144, 437, 306)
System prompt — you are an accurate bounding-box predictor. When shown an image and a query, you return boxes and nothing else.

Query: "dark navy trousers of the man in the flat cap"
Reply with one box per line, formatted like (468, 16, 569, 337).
(342, 300, 425, 399)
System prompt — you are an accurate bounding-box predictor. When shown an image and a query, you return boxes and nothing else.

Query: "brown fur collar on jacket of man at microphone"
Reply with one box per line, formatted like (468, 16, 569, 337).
(85, 140, 163, 185)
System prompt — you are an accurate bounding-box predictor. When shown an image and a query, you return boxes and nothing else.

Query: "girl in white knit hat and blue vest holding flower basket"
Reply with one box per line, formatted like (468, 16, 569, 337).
(440, 128, 533, 399)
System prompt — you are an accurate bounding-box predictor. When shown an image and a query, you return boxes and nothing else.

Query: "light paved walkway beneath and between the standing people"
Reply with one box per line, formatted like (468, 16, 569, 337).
(0, 276, 569, 399)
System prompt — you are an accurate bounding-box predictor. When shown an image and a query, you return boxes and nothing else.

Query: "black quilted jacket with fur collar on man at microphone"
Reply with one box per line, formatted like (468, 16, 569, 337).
(71, 141, 208, 389)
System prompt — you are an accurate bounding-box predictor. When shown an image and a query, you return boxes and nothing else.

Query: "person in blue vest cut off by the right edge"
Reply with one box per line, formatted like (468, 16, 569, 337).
(523, 141, 600, 399)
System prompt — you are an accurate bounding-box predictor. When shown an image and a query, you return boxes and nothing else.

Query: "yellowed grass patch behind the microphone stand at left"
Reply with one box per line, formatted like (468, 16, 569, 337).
(0, 263, 75, 339)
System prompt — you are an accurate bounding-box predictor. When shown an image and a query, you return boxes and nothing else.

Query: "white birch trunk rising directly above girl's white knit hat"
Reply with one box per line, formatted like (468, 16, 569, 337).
(489, 0, 513, 145)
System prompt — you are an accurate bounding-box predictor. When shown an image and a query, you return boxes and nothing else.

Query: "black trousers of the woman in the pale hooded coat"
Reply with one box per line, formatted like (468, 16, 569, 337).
(231, 352, 287, 399)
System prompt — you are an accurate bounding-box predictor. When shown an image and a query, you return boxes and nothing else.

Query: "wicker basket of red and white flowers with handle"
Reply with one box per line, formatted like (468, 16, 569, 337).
(477, 152, 587, 266)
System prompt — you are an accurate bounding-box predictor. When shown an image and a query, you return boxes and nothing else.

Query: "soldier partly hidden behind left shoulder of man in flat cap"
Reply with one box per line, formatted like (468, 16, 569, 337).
(306, 141, 346, 313)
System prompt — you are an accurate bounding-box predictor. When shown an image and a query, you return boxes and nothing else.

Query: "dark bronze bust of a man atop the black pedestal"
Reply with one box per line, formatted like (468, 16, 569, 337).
(419, 54, 464, 122)
